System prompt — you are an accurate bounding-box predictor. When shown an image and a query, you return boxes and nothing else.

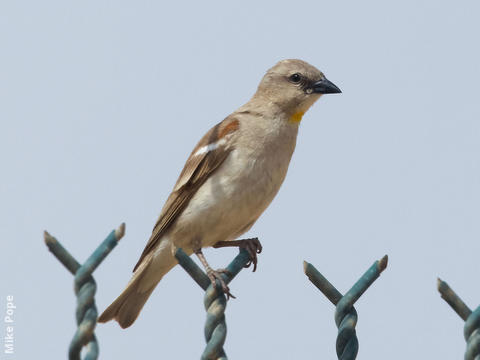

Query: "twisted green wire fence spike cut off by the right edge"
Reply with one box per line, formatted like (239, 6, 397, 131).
(437, 279, 480, 360)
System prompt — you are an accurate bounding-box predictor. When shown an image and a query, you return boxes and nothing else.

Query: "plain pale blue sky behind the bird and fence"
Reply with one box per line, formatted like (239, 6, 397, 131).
(0, 1, 480, 360)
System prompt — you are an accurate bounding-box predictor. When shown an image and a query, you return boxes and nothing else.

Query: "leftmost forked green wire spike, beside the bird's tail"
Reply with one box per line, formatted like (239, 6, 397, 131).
(43, 223, 125, 360)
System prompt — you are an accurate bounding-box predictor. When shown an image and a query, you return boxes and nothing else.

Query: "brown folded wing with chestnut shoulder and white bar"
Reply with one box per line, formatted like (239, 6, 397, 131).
(133, 116, 239, 271)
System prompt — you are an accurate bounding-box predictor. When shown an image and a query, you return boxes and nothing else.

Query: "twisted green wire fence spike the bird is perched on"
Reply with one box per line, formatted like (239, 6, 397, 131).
(175, 248, 250, 360)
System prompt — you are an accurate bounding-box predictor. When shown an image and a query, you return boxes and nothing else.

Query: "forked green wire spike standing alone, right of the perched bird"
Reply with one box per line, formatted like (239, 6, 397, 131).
(303, 255, 388, 360)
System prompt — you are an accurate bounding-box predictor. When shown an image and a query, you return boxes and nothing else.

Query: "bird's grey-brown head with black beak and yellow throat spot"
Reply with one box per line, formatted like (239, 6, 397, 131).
(255, 59, 341, 122)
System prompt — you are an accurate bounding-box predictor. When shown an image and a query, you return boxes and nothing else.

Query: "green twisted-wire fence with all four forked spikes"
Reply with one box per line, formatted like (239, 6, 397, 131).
(44, 224, 480, 360)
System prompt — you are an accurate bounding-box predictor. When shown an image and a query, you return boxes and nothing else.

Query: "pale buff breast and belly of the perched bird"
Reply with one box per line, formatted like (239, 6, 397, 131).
(172, 119, 296, 246)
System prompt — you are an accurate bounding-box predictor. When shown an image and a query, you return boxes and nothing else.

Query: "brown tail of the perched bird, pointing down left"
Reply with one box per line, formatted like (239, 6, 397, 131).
(98, 243, 176, 329)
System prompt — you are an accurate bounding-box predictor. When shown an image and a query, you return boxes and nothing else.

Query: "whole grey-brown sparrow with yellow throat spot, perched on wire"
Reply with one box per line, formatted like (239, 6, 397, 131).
(98, 59, 341, 328)
